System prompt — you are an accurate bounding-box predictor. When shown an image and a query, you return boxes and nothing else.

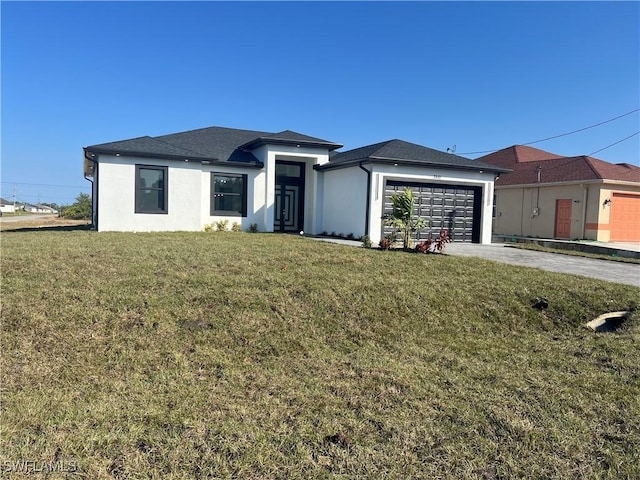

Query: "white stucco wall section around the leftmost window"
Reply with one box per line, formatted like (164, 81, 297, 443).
(97, 155, 202, 232)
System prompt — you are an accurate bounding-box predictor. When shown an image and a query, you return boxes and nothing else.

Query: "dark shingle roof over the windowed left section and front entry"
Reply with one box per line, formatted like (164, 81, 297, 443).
(85, 127, 342, 166)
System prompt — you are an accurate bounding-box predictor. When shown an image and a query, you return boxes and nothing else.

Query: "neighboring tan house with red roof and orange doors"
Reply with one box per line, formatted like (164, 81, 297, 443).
(478, 145, 640, 242)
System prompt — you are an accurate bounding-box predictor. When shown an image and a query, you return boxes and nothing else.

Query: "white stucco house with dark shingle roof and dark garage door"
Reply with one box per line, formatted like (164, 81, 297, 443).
(83, 127, 507, 243)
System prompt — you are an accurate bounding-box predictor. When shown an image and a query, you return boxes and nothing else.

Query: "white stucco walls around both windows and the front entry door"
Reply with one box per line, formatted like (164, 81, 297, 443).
(94, 145, 336, 234)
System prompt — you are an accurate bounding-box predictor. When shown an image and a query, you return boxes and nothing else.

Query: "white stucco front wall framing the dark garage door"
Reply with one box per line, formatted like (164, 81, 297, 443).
(363, 164, 494, 244)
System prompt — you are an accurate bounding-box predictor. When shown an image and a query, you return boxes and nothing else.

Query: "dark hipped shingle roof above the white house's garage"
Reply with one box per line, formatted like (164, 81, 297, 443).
(318, 140, 507, 172)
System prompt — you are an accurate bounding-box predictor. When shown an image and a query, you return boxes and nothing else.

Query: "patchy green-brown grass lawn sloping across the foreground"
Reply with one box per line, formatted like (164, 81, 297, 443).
(0, 231, 640, 479)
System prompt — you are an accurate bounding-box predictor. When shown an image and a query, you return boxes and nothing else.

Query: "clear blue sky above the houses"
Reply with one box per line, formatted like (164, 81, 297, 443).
(0, 1, 640, 204)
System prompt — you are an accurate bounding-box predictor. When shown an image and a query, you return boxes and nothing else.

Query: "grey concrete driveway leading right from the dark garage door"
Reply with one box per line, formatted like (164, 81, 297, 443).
(445, 243, 640, 287)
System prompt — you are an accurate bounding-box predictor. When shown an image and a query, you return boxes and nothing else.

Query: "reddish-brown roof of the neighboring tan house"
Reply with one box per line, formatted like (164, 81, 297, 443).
(478, 145, 640, 187)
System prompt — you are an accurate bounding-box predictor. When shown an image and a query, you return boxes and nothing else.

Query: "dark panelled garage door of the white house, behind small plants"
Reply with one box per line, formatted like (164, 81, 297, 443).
(382, 180, 482, 243)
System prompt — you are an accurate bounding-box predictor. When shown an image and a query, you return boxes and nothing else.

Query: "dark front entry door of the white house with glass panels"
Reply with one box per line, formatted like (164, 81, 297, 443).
(273, 161, 305, 232)
